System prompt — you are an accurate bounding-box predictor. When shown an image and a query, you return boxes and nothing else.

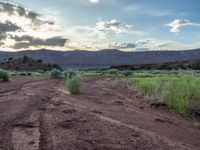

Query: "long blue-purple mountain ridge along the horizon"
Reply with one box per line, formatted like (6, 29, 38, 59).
(0, 49, 200, 69)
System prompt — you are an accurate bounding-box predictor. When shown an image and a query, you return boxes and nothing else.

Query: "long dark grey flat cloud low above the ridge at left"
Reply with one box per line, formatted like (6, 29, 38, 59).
(12, 35, 68, 49)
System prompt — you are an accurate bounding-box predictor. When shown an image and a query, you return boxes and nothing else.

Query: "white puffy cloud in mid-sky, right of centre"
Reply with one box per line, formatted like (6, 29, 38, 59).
(96, 19, 141, 36)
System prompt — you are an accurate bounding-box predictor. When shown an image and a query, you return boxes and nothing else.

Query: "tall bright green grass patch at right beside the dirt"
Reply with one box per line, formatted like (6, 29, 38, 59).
(132, 75, 200, 116)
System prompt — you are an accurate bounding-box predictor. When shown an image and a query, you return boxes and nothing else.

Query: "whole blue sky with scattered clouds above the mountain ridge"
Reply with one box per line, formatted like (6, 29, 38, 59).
(0, 0, 200, 51)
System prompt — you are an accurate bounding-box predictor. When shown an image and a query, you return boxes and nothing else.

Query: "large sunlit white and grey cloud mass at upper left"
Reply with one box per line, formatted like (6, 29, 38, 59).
(0, 2, 68, 49)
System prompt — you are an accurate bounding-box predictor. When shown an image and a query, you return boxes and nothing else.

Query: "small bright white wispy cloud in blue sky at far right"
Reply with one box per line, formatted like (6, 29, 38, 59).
(166, 19, 200, 33)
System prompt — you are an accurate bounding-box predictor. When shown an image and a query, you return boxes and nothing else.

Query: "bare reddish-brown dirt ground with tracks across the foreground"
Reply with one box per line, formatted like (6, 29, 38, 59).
(0, 77, 200, 150)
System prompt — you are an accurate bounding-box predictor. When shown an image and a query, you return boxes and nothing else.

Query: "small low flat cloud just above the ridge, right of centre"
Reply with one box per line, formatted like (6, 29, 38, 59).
(108, 42, 136, 49)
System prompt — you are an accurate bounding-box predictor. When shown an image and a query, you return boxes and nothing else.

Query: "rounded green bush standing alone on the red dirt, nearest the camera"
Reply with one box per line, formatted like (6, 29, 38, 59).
(66, 75, 81, 94)
